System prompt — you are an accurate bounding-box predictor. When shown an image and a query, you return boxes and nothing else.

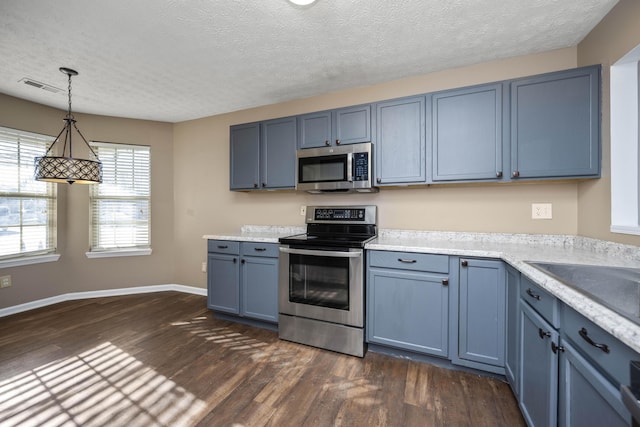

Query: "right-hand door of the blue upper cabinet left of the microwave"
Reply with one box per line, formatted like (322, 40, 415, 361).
(260, 117, 298, 188)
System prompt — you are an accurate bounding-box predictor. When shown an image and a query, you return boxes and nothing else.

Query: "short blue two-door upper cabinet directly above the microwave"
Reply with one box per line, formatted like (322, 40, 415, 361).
(298, 104, 371, 148)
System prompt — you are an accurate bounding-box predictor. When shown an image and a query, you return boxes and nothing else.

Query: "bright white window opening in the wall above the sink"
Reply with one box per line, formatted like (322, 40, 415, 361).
(611, 46, 640, 235)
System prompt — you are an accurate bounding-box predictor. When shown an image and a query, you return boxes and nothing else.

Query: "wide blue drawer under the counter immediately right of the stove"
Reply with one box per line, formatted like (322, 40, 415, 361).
(369, 251, 449, 273)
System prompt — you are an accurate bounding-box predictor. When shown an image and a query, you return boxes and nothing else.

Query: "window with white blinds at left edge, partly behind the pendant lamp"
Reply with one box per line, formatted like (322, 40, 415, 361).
(0, 127, 57, 260)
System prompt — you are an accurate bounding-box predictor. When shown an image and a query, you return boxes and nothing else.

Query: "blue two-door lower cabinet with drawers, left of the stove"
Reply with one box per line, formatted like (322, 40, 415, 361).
(207, 240, 278, 323)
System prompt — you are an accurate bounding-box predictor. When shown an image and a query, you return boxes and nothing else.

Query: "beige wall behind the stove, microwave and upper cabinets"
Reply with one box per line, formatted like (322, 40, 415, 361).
(174, 48, 578, 287)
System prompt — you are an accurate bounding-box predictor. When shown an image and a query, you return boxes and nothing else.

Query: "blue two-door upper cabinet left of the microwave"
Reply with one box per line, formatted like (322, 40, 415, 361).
(229, 117, 297, 190)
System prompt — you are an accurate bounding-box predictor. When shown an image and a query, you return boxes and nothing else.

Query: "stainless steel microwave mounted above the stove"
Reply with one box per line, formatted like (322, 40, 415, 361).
(296, 142, 378, 193)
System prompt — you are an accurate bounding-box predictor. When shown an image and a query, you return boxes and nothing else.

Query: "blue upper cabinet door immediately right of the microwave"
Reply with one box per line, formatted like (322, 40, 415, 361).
(374, 96, 430, 185)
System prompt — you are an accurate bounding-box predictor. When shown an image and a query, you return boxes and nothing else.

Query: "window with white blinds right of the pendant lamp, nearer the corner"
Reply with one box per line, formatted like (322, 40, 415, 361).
(87, 142, 151, 257)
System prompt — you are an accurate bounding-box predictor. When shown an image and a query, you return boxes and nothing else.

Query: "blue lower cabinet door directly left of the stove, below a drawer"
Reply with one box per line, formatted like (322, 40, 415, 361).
(241, 257, 278, 323)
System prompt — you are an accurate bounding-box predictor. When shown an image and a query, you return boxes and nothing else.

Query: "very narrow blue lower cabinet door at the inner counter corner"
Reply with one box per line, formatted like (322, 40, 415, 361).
(504, 266, 520, 397)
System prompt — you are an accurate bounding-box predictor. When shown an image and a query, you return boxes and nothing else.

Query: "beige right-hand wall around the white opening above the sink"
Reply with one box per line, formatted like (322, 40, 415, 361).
(578, 0, 640, 246)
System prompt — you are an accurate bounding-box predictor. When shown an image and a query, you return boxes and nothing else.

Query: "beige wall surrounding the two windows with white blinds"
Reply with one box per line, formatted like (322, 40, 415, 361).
(0, 94, 174, 308)
